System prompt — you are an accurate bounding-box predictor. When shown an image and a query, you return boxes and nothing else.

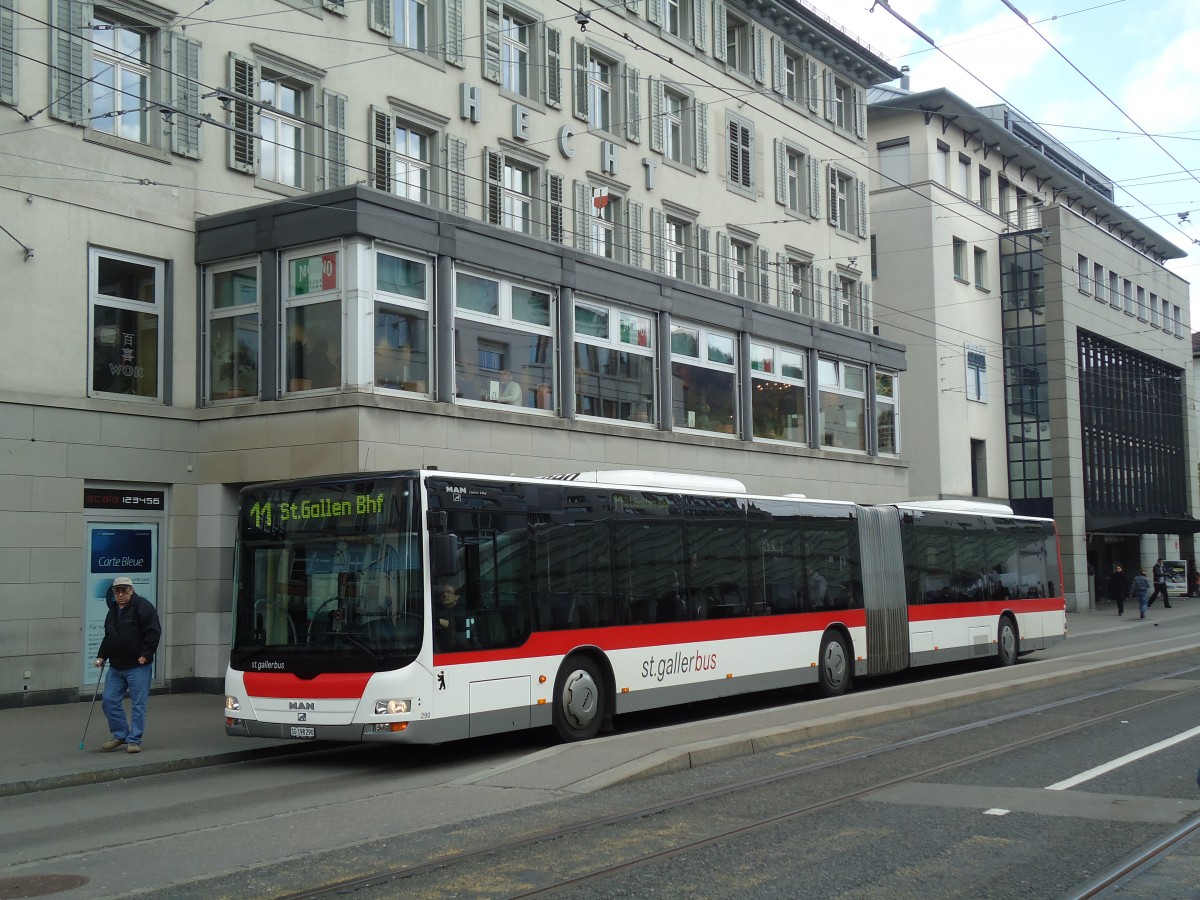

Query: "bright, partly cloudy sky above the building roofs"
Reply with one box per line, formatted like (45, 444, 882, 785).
(800, 0, 1200, 321)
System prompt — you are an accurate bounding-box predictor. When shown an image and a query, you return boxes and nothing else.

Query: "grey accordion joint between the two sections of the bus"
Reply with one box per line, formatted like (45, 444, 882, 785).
(858, 506, 908, 674)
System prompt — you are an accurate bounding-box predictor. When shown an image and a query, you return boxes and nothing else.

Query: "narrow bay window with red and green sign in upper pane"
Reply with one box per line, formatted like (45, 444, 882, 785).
(283, 250, 342, 392)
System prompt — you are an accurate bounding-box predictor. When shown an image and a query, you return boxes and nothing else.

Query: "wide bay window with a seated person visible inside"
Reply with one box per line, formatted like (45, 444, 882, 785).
(454, 271, 556, 412)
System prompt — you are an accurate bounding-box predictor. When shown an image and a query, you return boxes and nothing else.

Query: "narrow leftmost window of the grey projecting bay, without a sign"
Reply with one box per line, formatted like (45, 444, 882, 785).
(204, 260, 260, 401)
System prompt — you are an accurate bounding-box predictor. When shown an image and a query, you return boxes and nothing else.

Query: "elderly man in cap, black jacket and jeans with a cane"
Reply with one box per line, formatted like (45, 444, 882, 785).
(95, 575, 162, 754)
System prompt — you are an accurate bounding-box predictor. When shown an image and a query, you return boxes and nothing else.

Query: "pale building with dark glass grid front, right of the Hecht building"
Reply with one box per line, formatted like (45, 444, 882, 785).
(869, 89, 1196, 610)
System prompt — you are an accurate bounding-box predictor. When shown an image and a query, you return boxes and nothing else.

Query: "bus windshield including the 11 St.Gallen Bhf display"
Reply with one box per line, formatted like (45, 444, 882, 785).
(230, 478, 424, 674)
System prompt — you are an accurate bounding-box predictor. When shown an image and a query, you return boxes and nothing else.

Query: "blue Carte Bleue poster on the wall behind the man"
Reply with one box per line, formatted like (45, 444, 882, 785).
(80, 522, 162, 688)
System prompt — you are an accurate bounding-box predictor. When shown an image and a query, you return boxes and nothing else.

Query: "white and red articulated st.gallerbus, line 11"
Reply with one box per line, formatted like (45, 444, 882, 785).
(226, 469, 1066, 743)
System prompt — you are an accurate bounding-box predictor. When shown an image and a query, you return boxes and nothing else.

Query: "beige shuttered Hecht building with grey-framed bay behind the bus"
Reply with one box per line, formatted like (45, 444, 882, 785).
(0, 0, 908, 706)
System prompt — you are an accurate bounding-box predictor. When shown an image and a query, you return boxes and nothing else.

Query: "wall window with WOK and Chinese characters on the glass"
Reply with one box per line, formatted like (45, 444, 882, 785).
(88, 248, 166, 401)
